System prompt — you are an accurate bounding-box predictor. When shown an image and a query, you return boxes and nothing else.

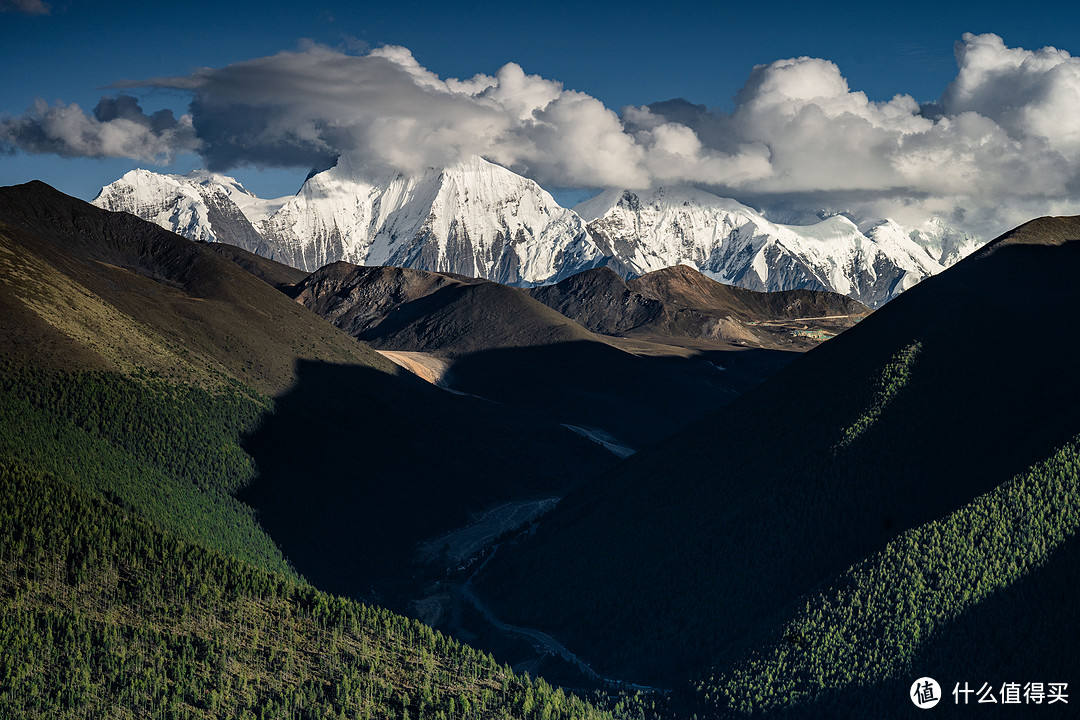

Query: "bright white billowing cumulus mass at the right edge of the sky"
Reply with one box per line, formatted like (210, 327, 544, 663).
(623, 35, 1080, 234)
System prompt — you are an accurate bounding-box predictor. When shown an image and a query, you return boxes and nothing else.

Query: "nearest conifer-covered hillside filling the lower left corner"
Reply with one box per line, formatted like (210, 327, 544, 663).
(0, 460, 622, 719)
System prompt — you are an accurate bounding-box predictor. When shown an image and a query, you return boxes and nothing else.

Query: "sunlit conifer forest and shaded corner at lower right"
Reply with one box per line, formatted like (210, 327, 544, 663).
(698, 438, 1080, 717)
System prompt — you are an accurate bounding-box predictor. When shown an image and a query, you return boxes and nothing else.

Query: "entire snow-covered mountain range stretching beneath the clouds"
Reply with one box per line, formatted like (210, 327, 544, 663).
(94, 158, 980, 307)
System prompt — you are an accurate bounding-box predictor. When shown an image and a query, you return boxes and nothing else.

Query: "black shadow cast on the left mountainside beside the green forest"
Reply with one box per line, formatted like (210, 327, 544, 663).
(241, 361, 616, 598)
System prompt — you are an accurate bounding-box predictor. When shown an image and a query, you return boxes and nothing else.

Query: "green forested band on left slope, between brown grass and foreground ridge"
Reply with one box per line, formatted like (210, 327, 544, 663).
(0, 365, 289, 572)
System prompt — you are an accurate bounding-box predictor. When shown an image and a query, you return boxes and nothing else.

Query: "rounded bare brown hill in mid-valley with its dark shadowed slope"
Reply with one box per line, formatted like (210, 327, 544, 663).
(294, 262, 797, 449)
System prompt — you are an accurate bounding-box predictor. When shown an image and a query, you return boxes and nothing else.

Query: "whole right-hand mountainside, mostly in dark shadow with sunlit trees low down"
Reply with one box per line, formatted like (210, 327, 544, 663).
(480, 218, 1080, 703)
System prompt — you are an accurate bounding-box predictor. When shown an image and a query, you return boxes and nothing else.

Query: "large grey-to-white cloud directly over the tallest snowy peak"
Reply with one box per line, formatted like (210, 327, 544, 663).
(122, 45, 650, 187)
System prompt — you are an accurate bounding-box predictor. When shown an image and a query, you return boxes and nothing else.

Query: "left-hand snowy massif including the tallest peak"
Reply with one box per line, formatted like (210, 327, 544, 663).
(94, 158, 603, 285)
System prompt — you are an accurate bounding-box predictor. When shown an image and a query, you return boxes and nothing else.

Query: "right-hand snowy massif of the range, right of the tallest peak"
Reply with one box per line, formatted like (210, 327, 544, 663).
(575, 188, 978, 307)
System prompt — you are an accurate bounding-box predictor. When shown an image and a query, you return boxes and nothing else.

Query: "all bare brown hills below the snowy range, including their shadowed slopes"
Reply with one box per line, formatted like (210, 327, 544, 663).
(286, 261, 869, 450)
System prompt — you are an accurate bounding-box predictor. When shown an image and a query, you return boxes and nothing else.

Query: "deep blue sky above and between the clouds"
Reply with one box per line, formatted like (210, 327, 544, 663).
(0, 0, 1080, 234)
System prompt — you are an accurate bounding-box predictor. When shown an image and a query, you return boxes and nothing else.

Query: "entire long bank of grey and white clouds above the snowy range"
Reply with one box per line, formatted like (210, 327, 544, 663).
(6, 35, 1080, 232)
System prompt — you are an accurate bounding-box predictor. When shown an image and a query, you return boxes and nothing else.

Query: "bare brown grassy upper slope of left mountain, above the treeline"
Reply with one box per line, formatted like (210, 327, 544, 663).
(0, 182, 396, 395)
